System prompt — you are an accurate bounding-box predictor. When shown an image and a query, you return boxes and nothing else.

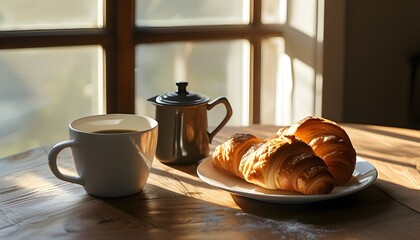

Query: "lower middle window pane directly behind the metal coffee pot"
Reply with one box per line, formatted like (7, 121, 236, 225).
(136, 40, 250, 127)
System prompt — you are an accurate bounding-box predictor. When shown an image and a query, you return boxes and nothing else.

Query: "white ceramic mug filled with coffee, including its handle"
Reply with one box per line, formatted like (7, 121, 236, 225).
(48, 114, 158, 197)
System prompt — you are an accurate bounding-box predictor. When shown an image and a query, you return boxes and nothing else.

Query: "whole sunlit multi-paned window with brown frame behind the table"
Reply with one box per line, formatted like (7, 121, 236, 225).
(0, 0, 322, 157)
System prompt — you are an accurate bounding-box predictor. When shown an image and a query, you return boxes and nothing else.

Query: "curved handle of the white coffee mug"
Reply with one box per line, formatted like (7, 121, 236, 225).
(48, 140, 84, 185)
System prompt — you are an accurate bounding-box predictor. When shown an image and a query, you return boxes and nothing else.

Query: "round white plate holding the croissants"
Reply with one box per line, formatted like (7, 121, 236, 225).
(197, 156, 378, 204)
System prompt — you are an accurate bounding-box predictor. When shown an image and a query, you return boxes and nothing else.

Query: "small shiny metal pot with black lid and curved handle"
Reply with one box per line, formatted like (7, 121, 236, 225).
(148, 82, 232, 164)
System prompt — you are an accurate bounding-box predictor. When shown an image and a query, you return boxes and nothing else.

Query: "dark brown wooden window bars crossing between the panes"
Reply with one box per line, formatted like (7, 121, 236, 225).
(0, 0, 283, 124)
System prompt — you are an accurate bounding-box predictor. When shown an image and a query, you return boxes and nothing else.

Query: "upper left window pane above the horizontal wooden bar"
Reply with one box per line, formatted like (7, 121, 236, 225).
(0, 0, 103, 30)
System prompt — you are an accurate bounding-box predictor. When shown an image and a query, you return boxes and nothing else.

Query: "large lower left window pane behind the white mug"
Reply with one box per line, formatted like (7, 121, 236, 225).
(0, 46, 103, 157)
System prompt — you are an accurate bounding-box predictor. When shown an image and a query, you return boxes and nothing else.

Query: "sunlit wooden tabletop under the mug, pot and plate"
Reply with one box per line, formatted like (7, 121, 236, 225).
(0, 124, 420, 240)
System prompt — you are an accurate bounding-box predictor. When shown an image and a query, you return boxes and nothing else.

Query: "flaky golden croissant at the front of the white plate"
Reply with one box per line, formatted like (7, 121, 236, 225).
(212, 133, 334, 194)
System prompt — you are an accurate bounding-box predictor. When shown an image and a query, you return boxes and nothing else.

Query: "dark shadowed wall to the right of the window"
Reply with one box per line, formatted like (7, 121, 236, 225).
(323, 0, 420, 127)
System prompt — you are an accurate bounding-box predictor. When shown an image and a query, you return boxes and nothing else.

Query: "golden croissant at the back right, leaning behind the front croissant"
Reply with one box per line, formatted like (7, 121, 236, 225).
(277, 117, 356, 185)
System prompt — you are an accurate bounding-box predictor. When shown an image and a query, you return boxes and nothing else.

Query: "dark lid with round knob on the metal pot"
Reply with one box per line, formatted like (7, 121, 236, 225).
(156, 82, 210, 106)
